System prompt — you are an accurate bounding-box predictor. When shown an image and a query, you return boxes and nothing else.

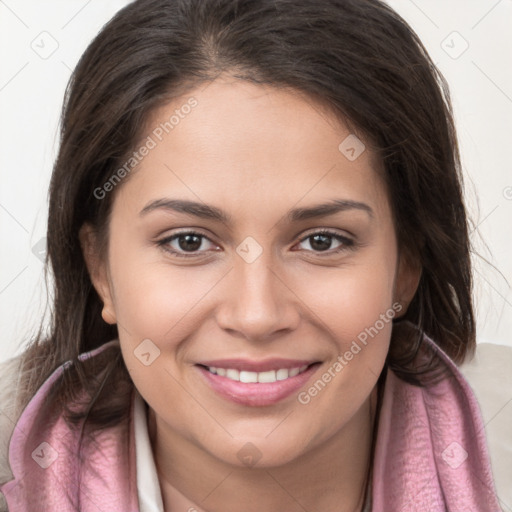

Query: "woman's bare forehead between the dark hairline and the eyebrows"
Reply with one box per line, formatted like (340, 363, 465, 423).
(114, 77, 389, 222)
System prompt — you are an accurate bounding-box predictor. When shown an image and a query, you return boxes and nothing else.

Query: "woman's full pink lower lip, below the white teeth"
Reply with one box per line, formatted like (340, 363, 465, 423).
(197, 363, 319, 407)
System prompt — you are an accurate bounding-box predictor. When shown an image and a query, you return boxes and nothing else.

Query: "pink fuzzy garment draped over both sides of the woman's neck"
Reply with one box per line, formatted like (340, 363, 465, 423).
(0, 338, 501, 512)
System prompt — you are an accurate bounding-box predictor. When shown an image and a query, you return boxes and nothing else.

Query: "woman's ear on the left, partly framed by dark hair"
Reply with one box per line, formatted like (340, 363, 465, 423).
(78, 223, 117, 324)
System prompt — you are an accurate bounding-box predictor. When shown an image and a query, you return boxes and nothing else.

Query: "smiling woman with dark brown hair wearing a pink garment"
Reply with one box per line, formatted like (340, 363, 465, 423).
(0, 0, 506, 512)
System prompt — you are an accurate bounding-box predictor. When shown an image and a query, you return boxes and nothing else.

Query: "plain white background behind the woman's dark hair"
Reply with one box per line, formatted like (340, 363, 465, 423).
(0, 0, 512, 361)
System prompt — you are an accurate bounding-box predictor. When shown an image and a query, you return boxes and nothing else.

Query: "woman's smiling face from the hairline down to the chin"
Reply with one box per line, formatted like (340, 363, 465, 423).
(85, 78, 420, 466)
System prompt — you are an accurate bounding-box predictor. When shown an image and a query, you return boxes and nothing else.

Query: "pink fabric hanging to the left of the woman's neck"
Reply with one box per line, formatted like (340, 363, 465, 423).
(0, 341, 139, 512)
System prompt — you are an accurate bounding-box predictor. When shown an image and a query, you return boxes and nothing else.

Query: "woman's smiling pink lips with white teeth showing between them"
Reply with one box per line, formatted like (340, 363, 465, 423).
(196, 359, 320, 407)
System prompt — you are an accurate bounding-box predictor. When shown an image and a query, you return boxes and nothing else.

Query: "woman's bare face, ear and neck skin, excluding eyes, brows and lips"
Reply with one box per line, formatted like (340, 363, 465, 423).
(81, 76, 419, 512)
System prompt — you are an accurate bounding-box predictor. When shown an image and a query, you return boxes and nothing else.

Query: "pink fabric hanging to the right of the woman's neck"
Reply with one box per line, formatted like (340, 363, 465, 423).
(372, 337, 501, 512)
